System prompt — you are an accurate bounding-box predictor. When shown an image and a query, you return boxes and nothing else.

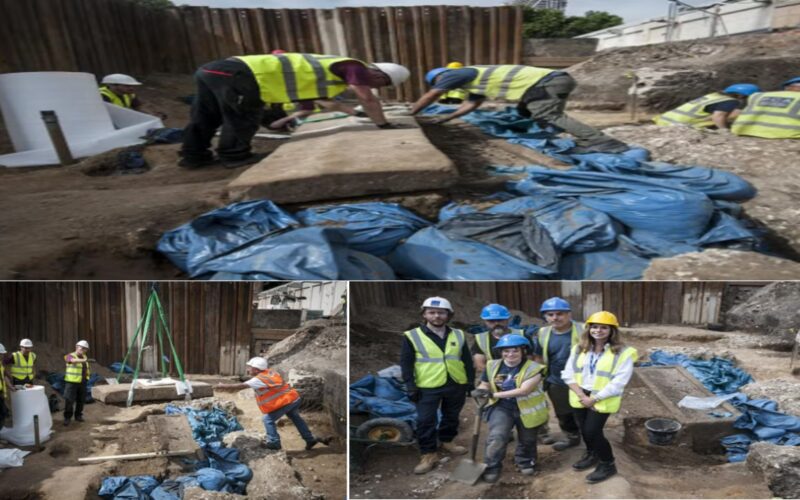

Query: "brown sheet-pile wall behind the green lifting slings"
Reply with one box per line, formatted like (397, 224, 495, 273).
(0, 282, 255, 375)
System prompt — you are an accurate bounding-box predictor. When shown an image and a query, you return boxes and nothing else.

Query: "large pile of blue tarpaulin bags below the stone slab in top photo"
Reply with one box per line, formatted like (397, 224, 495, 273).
(157, 105, 769, 280)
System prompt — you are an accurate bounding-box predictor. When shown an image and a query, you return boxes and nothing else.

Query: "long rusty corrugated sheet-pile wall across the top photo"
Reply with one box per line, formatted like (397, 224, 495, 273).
(0, 0, 523, 101)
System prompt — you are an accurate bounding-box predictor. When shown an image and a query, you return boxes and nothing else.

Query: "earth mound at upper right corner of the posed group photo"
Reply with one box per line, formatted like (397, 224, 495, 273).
(724, 281, 800, 335)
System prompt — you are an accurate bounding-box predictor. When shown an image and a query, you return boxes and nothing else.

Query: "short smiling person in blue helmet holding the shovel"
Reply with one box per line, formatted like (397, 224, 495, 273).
(473, 334, 548, 483)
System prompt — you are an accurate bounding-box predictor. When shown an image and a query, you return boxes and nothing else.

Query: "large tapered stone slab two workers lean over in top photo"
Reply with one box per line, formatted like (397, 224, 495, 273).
(228, 117, 458, 203)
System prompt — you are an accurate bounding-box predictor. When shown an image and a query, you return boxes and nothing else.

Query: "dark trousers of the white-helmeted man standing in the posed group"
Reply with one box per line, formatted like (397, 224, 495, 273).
(417, 385, 467, 453)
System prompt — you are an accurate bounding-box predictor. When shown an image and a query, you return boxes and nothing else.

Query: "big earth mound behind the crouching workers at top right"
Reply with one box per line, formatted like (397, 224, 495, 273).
(569, 29, 800, 111)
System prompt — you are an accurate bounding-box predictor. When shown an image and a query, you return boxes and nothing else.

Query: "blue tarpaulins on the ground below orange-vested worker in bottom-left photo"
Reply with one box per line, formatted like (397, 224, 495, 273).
(98, 405, 253, 500)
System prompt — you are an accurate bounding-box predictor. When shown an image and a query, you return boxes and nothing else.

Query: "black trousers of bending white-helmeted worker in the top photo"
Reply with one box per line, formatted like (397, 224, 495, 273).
(181, 59, 264, 161)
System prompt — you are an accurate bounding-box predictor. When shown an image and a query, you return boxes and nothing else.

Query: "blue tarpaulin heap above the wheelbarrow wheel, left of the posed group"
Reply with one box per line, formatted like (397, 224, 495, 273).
(350, 374, 417, 429)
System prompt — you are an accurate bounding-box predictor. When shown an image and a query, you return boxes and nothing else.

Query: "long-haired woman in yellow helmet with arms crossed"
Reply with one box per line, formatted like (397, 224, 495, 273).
(561, 311, 638, 483)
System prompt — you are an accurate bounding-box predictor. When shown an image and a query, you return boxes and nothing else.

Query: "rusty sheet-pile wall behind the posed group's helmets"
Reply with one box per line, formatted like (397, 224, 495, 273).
(350, 281, 766, 325)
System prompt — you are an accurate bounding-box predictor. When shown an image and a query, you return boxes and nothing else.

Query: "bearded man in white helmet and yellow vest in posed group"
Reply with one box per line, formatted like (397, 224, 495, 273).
(400, 297, 475, 474)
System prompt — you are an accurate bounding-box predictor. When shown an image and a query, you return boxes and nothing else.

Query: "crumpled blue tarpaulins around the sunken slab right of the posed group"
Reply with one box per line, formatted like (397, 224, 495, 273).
(643, 351, 800, 462)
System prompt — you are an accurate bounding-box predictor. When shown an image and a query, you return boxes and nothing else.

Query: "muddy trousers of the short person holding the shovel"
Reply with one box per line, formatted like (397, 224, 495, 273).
(483, 406, 539, 472)
